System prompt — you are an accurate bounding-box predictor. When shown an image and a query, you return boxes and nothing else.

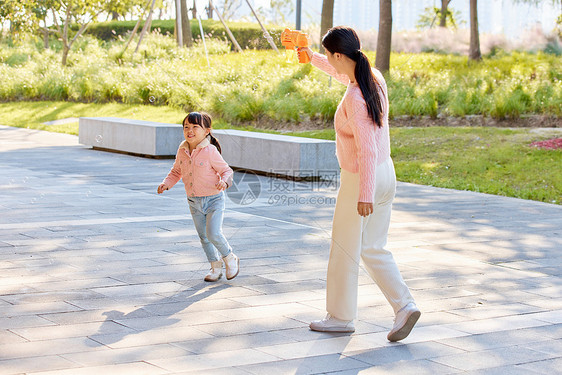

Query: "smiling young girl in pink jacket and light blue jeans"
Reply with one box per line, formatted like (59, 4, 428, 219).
(158, 112, 240, 281)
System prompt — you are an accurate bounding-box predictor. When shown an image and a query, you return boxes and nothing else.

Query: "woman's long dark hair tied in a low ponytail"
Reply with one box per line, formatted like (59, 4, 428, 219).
(322, 26, 383, 127)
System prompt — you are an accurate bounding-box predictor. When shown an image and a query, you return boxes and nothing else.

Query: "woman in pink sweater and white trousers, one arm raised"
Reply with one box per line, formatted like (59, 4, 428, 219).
(299, 26, 421, 341)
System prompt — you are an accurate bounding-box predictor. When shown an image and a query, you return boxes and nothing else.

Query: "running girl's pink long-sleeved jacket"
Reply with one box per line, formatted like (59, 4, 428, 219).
(162, 138, 234, 197)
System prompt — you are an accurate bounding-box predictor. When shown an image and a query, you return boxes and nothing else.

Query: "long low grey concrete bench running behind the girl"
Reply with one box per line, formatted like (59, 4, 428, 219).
(78, 117, 339, 179)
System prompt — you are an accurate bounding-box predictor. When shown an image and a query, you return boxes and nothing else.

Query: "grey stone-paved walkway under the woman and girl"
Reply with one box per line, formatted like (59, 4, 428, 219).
(0, 127, 562, 375)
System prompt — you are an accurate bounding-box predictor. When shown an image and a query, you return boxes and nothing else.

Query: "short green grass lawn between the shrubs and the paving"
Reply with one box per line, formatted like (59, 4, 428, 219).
(0, 102, 562, 204)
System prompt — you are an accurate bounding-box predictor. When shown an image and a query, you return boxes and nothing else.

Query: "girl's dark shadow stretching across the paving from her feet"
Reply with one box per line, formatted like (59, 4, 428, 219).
(87, 283, 230, 347)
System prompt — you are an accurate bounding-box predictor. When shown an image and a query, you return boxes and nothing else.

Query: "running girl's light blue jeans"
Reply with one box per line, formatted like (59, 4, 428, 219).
(187, 191, 232, 262)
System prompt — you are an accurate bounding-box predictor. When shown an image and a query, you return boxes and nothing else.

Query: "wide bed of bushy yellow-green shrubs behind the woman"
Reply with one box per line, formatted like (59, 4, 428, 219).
(0, 33, 562, 123)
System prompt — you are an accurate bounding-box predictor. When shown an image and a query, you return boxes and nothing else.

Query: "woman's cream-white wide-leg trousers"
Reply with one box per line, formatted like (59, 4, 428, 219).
(326, 158, 414, 320)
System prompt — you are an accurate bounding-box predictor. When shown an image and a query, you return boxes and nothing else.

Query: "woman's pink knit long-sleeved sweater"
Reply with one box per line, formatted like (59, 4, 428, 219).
(312, 53, 390, 203)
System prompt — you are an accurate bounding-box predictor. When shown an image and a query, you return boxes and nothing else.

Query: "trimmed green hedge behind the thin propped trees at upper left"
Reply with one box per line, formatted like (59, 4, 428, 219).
(79, 20, 283, 49)
